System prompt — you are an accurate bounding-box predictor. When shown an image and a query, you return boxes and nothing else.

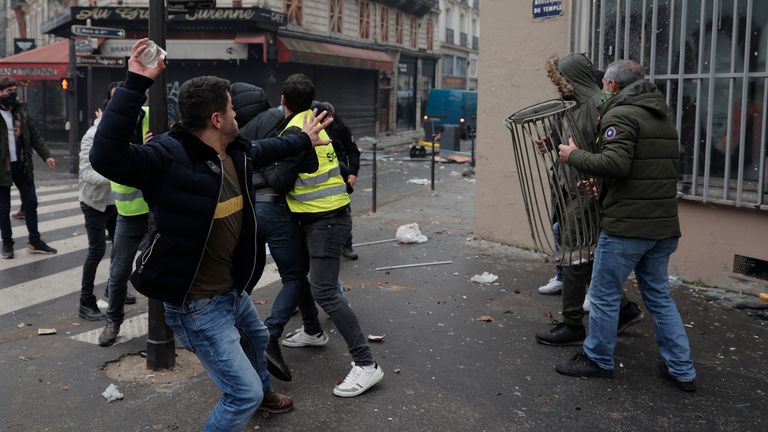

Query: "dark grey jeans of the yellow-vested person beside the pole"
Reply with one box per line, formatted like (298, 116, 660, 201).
(107, 214, 149, 325)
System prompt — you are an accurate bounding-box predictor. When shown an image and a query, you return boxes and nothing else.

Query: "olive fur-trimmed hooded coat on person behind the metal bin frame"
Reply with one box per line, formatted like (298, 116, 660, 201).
(546, 54, 601, 247)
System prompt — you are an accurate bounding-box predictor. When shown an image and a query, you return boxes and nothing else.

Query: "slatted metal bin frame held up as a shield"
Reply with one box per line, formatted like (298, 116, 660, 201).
(505, 100, 600, 265)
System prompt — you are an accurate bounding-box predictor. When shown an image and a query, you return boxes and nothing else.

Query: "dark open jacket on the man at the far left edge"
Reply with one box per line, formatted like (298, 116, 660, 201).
(0, 104, 51, 186)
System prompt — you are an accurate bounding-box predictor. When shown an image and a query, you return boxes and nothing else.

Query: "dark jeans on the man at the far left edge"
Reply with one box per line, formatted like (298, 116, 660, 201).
(0, 161, 40, 245)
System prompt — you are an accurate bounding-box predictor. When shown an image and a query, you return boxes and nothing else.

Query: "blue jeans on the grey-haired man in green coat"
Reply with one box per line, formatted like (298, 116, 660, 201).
(584, 232, 696, 381)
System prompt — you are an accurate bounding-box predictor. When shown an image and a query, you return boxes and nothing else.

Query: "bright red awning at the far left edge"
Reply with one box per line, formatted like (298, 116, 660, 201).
(0, 40, 69, 80)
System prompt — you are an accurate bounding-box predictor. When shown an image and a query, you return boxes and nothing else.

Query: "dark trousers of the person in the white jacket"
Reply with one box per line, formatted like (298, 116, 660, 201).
(80, 201, 116, 307)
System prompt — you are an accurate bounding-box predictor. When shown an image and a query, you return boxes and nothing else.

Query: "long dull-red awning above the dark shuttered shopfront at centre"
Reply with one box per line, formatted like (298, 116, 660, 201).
(277, 36, 394, 71)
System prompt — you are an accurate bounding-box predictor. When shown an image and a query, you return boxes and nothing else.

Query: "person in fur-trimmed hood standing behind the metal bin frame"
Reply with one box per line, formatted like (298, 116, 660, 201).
(536, 53, 643, 345)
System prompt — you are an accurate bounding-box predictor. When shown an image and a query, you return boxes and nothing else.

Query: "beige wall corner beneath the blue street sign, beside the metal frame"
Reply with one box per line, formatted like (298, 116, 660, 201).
(475, 0, 568, 247)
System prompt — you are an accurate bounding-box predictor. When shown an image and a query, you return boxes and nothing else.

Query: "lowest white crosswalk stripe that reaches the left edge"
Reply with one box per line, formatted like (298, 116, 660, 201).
(0, 259, 109, 316)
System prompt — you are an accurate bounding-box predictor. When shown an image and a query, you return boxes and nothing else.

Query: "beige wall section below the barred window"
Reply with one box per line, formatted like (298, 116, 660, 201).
(670, 200, 768, 291)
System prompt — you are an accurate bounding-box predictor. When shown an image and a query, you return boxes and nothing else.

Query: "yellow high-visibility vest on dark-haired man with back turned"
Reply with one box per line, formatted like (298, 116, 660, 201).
(280, 110, 350, 213)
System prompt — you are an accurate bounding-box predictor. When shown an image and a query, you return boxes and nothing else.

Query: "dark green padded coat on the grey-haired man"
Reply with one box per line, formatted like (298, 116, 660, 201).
(568, 80, 680, 239)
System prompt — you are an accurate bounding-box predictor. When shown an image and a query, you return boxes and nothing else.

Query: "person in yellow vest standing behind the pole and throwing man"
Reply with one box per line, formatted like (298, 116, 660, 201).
(99, 107, 149, 347)
